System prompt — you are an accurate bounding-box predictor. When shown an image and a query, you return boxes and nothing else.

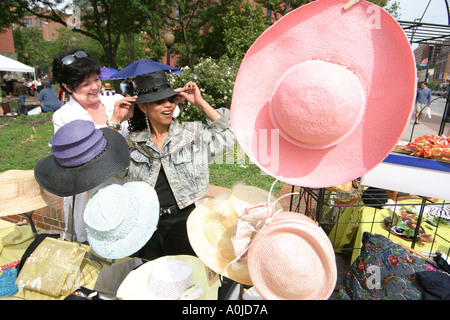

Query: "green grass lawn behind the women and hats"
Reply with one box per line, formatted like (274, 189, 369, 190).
(0, 113, 283, 195)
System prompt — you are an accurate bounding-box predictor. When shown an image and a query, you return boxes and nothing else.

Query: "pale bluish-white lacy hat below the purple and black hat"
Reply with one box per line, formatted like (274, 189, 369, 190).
(84, 182, 159, 259)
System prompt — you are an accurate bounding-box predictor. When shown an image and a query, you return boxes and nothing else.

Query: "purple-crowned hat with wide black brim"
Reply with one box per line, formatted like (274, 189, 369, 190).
(34, 120, 130, 197)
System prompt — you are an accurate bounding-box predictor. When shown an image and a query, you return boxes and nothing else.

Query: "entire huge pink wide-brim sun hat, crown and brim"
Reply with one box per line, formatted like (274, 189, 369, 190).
(231, 0, 416, 188)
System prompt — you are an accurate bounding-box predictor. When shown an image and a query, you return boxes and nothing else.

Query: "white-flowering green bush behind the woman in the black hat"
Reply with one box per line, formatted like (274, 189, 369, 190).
(169, 57, 239, 121)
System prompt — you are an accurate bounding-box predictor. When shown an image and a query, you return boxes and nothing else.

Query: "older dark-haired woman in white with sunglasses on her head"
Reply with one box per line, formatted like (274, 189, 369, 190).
(53, 50, 137, 242)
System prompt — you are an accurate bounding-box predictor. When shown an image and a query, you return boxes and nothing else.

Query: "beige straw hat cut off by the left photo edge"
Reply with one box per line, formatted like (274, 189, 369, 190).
(0, 170, 53, 217)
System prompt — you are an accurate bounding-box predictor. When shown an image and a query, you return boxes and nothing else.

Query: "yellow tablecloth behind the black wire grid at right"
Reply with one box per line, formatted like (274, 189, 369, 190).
(329, 199, 450, 262)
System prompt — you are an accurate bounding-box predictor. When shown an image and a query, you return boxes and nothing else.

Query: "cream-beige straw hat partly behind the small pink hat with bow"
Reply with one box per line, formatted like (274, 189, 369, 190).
(187, 185, 281, 285)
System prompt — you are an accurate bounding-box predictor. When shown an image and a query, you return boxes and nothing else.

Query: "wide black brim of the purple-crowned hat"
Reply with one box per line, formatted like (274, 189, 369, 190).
(34, 128, 130, 197)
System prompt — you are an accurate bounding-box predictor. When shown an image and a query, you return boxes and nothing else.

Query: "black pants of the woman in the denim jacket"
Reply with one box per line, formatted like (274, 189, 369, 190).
(137, 204, 196, 260)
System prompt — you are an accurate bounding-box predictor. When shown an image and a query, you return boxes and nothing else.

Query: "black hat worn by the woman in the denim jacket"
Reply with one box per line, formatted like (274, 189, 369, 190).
(136, 71, 178, 103)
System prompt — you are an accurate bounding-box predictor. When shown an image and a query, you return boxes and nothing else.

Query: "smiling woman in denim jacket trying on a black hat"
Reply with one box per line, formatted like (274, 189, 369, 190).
(111, 71, 235, 260)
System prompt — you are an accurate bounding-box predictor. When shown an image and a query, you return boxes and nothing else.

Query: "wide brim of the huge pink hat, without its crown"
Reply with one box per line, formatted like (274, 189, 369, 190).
(231, 0, 416, 187)
